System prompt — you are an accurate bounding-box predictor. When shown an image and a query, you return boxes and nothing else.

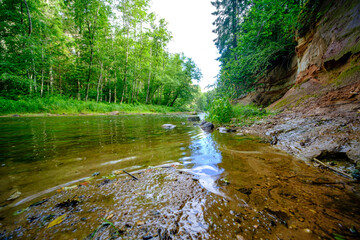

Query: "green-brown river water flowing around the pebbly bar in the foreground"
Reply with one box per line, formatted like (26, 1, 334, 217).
(0, 115, 360, 239)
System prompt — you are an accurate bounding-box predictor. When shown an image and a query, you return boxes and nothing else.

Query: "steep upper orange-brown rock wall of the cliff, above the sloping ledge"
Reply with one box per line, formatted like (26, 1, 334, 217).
(296, 0, 360, 83)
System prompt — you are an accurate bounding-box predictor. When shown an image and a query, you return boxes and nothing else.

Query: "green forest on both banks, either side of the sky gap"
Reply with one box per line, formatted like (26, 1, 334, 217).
(0, 0, 334, 116)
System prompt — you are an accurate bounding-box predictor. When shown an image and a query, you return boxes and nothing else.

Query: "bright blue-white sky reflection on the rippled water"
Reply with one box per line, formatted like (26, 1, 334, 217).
(180, 128, 224, 195)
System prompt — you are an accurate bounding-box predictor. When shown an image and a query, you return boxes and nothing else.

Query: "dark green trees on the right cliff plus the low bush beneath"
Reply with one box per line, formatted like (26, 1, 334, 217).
(209, 0, 322, 123)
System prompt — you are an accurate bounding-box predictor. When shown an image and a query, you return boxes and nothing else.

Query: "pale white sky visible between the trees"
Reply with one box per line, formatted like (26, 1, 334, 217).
(151, 0, 220, 91)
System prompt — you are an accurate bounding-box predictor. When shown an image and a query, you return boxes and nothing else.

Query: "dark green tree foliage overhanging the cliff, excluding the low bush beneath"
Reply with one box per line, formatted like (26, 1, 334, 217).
(214, 0, 300, 98)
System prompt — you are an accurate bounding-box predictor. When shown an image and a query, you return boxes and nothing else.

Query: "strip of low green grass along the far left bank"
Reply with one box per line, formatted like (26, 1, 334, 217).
(0, 96, 188, 115)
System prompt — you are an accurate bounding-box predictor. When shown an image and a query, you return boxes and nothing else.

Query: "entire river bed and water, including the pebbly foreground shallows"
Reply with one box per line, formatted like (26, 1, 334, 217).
(0, 115, 360, 239)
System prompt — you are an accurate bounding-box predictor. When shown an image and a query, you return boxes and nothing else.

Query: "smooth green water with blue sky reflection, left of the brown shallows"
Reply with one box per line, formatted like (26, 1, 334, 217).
(0, 115, 228, 206)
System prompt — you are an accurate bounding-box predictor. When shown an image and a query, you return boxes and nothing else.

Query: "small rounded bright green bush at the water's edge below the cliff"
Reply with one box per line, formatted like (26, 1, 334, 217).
(206, 98, 234, 123)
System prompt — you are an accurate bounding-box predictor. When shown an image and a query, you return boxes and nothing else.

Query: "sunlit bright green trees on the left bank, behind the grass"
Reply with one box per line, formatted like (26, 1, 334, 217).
(0, 0, 201, 112)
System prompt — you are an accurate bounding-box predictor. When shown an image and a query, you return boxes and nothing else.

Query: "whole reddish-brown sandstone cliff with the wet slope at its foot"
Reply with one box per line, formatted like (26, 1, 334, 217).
(239, 0, 360, 169)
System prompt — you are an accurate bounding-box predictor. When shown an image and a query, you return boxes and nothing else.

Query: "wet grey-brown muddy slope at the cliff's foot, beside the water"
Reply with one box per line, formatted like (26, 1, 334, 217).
(231, 104, 360, 178)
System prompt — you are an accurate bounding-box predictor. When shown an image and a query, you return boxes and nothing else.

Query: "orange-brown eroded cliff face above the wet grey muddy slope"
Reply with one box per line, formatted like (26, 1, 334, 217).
(237, 0, 360, 110)
